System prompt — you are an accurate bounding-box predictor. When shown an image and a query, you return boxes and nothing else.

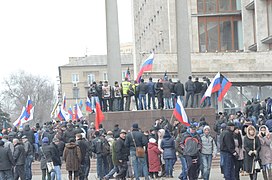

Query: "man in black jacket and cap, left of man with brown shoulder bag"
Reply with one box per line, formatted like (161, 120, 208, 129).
(114, 129, 129, 179)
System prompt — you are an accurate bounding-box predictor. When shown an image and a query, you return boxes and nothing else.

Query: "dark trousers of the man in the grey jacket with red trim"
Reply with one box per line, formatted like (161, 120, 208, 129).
(184, 156, 200, 180)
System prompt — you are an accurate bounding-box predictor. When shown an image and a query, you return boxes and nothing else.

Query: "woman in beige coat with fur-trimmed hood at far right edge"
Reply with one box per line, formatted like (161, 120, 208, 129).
(258, 125, 272, 180)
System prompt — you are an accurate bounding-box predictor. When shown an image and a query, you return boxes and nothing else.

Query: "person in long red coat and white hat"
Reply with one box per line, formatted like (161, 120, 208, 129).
(147, 138, 161, 179)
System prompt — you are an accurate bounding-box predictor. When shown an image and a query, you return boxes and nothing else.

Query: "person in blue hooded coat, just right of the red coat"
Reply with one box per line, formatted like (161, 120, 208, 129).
(161, 130, 177, 178)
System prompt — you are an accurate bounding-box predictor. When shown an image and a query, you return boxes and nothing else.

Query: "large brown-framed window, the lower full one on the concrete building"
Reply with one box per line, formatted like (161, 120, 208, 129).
(198, 15, 243, 52)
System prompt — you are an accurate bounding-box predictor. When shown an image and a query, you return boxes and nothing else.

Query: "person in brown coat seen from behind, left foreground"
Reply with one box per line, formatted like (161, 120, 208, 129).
(63, 138, 82, 180)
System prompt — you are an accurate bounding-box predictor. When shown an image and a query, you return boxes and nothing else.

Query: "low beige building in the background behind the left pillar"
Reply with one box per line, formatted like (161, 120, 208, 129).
(59, 54, 133, 107)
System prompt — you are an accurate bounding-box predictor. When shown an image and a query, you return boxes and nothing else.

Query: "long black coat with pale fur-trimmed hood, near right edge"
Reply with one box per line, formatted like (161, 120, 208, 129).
(244, 126, 261, 174)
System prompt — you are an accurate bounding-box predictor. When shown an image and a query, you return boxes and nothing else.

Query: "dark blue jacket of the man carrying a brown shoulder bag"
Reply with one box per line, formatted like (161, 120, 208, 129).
(125, 129, 148, 151)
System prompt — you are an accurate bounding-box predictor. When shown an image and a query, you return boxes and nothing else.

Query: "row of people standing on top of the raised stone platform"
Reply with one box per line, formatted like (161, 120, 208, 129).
(88, 76, 211, 113)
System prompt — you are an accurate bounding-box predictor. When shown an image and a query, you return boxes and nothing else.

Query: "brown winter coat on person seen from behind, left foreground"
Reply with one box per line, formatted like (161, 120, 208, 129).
(63, 142, 81, 171)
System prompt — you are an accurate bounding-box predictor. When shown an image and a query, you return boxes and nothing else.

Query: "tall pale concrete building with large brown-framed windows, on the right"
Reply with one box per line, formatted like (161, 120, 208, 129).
(133, 0, 272, 111)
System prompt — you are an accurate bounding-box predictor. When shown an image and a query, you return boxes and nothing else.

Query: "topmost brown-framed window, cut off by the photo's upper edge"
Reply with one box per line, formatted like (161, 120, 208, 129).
(197, 0, 241, 14)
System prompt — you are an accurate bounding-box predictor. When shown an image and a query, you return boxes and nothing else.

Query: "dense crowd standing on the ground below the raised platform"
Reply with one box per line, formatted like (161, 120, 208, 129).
(0, 98, 272, 180)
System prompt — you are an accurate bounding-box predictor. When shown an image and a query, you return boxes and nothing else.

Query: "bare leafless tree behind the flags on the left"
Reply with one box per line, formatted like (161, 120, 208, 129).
(2, 71, 56, 125)
